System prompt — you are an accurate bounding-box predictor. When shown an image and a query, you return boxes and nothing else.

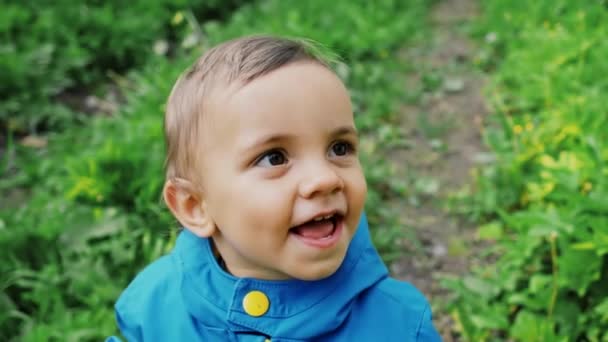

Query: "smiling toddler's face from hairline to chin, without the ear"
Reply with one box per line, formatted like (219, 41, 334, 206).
(201, 63, 367, 280)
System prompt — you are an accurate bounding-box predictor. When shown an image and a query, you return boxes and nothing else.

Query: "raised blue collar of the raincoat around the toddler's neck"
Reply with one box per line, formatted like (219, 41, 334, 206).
(174, 216, 388, 340)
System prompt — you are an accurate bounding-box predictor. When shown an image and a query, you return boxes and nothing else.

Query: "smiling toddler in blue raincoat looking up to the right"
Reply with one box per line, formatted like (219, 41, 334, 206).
(109, 36, 439, 342)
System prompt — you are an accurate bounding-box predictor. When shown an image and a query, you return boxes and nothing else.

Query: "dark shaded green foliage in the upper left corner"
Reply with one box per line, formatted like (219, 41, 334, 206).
(0, 0, 245, 133)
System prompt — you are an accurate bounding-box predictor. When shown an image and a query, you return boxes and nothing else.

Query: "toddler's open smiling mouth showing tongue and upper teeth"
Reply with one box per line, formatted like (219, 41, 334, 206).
(289, 213, 344, 247)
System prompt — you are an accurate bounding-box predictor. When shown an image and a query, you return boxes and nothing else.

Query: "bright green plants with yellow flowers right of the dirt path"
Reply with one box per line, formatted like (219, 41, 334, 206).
(446, 0, 608, 341)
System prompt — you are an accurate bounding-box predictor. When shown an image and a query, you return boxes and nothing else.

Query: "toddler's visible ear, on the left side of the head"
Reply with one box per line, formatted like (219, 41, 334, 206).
(163, 178, 216, 238)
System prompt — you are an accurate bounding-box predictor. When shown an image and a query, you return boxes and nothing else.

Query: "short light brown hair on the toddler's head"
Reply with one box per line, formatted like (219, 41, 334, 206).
(165, 36, 330, 187)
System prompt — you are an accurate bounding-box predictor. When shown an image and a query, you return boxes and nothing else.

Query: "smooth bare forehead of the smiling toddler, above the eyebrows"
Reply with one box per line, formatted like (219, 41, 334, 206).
(205, 62, 354, 144)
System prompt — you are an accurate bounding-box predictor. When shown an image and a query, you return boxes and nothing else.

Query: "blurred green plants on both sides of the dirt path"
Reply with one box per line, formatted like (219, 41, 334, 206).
(0, 0, 608, 341)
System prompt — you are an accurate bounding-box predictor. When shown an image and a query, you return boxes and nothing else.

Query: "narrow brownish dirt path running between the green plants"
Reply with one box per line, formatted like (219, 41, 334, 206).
(391, 0, 487, 341)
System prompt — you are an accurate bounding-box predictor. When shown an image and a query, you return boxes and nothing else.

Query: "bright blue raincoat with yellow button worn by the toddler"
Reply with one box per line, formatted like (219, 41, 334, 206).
(108, 216, 440, 342)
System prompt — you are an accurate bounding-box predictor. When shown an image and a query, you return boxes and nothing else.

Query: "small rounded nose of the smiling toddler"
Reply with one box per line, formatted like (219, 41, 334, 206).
(299, 161, 344, 198)
